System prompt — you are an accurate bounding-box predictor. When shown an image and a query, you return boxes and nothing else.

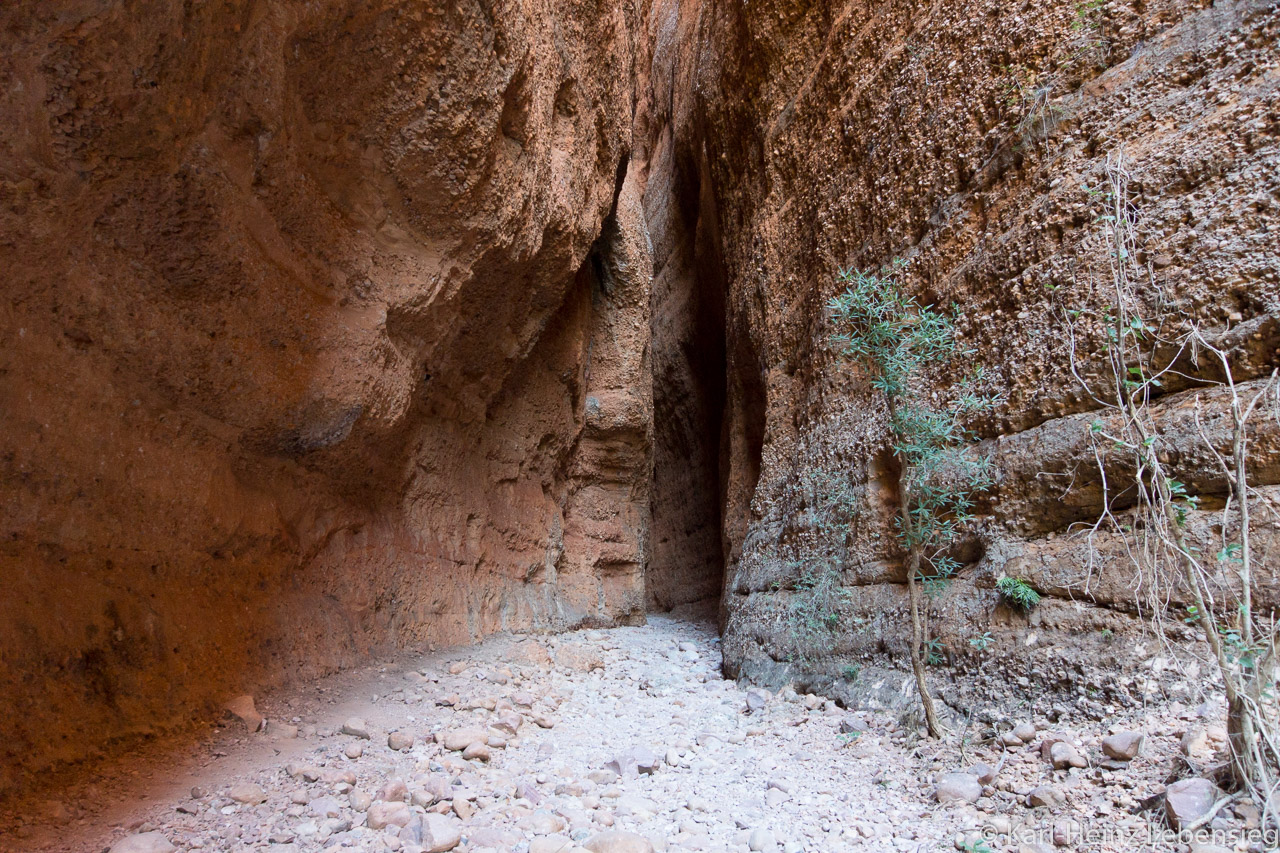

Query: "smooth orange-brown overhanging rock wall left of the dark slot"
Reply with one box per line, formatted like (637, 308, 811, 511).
(0, 0, 652, 789)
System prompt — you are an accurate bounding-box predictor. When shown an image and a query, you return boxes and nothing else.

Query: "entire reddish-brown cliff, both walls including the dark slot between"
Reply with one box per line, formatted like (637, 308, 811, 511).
(0, 0, 1280, 789)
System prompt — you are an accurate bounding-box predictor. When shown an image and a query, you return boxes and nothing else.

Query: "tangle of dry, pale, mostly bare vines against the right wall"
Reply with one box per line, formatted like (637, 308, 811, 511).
(1069, 152, 1280, 825)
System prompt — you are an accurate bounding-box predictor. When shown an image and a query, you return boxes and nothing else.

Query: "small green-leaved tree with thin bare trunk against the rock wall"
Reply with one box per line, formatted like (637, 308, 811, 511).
(829, 263, 996, 736)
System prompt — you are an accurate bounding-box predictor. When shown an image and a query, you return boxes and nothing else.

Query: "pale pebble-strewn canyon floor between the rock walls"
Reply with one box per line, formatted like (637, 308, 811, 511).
(0, 617, 1259, 853)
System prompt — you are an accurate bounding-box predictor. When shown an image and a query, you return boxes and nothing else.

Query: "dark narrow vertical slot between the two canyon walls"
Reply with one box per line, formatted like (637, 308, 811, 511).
(645, 156, 728, 616)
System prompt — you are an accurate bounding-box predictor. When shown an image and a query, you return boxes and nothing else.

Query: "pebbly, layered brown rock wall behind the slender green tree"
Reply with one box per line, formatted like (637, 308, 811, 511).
(646, 0, 1280, 708)
